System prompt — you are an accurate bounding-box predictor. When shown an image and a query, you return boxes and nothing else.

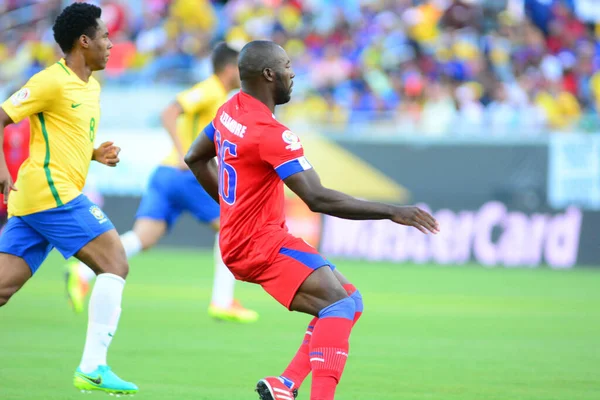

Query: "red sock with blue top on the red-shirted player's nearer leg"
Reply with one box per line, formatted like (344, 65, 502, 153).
(308, 297, 354, 400)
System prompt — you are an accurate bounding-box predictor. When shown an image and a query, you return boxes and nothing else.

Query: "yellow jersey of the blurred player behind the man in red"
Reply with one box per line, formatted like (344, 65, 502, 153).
(163, 75, 227, 167)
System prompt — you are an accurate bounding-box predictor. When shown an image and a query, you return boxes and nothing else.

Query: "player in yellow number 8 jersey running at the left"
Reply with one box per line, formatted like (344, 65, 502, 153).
(0, 3, 138, 394)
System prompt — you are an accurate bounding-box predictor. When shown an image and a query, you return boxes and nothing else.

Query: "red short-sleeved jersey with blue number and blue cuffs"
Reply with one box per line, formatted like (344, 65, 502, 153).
(210, 91, 312, 270)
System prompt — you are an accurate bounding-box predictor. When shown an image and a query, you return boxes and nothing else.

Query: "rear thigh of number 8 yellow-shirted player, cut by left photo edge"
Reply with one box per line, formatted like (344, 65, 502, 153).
(0, 217, 52, 305)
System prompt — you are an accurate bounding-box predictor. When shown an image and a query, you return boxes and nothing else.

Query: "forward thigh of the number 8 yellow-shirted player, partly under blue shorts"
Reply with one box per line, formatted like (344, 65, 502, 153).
(22, 195, 122, 275)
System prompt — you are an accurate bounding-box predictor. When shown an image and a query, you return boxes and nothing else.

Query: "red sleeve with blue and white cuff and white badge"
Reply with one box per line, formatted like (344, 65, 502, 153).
(259, 125, 312, 180)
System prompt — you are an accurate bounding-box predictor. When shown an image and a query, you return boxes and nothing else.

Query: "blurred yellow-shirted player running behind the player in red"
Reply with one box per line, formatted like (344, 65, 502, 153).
(67, 43, 258, 323)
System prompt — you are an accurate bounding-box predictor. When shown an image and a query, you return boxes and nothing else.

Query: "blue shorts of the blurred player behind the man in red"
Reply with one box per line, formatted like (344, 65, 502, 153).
(135, 166, 220, 228)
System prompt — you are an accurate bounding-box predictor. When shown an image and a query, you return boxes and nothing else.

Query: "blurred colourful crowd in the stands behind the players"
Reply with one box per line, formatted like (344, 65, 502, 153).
(0, 0, 600, 136)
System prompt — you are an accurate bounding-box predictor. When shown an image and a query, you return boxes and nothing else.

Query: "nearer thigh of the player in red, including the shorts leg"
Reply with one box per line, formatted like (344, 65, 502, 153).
(257, 235, 347, 315)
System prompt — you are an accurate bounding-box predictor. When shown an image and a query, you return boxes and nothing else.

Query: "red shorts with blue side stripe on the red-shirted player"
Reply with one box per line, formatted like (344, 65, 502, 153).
(232, 234, 335, 309)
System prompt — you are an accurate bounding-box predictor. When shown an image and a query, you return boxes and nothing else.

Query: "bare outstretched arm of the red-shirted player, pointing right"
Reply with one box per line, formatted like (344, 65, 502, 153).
(284, 168, 439, 233)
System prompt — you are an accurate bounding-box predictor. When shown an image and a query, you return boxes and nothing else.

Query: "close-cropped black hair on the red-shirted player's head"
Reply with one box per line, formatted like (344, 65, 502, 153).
(238, 40, 280, 81)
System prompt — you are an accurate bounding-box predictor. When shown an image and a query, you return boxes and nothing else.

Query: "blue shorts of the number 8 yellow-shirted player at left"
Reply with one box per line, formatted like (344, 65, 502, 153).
(0, 195, 115, 274)
